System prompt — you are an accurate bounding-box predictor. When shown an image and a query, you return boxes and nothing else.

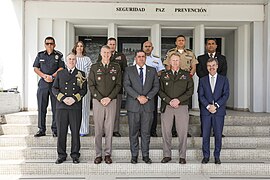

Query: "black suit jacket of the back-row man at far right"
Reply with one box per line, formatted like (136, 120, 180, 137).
(196, 53, 227, 78)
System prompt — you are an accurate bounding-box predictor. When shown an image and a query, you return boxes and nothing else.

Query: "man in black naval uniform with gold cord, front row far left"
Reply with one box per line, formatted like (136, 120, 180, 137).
(52, 53, 87, 164)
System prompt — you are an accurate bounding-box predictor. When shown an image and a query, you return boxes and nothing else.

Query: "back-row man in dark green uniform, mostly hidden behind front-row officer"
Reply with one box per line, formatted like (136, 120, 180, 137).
(98, 37, 127, 137)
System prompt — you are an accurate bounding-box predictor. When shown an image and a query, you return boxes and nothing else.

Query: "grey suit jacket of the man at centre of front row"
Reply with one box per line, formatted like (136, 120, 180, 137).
(123, 65, 159, 112)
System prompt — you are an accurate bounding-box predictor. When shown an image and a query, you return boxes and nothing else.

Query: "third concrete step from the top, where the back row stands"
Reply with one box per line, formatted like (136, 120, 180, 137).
(0, 135, 270, 150)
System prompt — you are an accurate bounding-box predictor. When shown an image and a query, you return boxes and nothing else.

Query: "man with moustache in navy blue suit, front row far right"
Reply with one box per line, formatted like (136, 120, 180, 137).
(198, 58, 230, 164)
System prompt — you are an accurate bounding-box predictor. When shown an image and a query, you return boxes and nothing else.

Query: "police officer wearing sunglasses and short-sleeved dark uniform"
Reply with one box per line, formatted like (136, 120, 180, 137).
(33, 37, 65, 137)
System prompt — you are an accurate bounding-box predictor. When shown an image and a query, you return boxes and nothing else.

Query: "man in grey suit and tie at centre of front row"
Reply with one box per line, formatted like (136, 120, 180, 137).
(123, 50, 159, 164)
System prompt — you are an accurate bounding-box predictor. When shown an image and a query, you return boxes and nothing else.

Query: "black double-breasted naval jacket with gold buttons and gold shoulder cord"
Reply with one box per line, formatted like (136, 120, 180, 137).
(52, 68, 87, 109)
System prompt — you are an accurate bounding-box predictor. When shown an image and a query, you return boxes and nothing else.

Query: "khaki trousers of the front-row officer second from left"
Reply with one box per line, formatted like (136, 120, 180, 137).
(93, 99, 116, 157)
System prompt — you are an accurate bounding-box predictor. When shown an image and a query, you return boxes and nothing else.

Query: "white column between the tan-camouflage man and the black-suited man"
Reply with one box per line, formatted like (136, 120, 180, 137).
(192, 24, 205, 109)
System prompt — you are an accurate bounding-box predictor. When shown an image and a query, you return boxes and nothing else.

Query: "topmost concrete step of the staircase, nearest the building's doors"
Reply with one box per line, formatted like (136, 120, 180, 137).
(3, 111, 270, 126)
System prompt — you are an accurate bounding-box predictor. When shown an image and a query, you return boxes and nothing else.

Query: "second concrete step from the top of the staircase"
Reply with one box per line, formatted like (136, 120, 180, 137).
(0, 124, 270, 137)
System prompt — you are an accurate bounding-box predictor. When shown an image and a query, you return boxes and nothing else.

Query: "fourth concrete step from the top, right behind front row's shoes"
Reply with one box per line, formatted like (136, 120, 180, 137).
(0, 147, 270, 162)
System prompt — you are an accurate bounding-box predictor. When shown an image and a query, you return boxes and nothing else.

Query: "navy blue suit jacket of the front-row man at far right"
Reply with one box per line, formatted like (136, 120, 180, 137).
(198, 74, 230, 116)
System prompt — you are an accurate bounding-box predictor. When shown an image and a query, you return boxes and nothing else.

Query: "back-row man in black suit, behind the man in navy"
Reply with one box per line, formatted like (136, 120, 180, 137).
(196, 38, 227, 137)
